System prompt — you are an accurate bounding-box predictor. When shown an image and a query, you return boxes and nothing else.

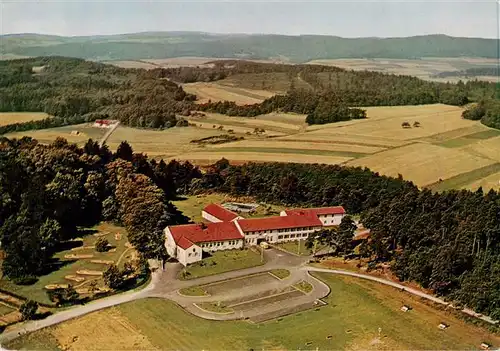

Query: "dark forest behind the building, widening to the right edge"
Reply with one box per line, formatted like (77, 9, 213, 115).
(191, 160, 500, 319)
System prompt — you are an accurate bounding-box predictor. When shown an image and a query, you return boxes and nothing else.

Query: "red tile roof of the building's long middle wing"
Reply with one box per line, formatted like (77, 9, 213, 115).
(234, 215, 321, 232)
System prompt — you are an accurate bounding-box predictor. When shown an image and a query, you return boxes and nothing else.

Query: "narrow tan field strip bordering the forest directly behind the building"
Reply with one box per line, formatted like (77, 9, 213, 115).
(171, 150, 351, 165)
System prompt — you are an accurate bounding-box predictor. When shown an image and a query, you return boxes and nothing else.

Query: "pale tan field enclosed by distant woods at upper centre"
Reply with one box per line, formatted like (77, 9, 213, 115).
(182, 82, 274, 105)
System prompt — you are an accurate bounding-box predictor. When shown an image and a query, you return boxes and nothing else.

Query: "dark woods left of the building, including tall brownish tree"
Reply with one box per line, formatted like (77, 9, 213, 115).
(0, 137, 201, 283)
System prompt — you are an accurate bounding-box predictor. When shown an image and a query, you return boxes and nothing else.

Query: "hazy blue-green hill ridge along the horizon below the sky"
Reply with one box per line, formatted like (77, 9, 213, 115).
(0, 31, 497, 62)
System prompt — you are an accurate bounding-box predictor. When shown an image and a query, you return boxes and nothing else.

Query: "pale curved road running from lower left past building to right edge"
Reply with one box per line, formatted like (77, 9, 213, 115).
(0, 250, 498, 344)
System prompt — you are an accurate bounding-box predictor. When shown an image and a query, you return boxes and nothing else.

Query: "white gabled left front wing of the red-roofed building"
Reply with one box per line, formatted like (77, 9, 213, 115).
(164, 222, 244, 266)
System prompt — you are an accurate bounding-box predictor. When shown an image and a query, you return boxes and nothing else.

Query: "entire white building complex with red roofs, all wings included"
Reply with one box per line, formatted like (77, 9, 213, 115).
(165, 204, 345, 266)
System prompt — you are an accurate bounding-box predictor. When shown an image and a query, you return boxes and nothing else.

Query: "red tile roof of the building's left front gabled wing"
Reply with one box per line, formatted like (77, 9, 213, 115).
(168, 222, 243, 249)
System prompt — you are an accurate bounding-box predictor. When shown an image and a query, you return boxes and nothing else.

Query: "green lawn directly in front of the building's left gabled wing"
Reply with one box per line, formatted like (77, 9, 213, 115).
(179, 249, 265, 280)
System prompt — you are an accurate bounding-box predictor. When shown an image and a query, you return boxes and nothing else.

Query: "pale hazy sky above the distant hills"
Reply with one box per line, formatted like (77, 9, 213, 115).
(0, 0, 500, 38)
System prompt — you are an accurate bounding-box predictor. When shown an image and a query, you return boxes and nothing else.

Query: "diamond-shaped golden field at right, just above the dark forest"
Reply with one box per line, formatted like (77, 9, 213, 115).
(348, 143, 495, 186)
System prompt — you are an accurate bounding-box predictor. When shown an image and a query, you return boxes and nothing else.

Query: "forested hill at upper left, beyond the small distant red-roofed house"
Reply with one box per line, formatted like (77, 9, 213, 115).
(0, 57, 196, 134)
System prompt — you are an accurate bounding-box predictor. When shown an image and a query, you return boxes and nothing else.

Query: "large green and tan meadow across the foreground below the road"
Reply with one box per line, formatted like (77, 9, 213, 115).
(6, 274, 500, 350)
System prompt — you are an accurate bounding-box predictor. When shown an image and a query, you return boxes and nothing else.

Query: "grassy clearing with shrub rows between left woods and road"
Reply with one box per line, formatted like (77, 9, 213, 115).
(0, 223, 134, 304)
